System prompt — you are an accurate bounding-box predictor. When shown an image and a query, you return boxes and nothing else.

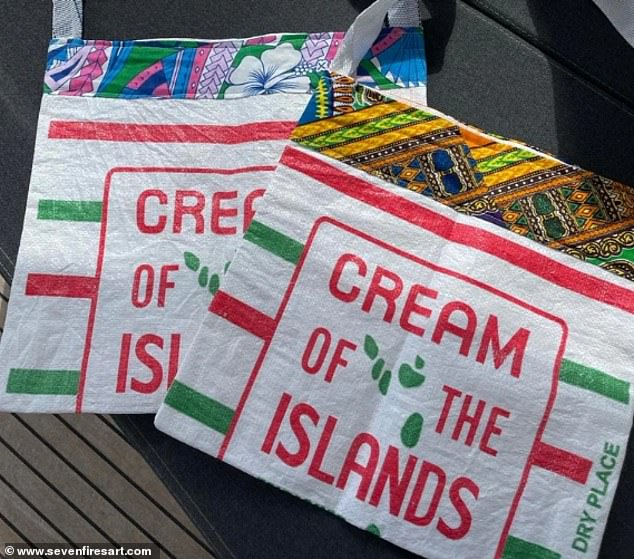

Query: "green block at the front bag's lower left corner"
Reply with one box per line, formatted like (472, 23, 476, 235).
(165, 380, 235, 435)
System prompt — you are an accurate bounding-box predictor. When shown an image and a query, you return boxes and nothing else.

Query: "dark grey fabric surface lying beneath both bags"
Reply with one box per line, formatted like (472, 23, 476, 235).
(0, 0, 634, 559)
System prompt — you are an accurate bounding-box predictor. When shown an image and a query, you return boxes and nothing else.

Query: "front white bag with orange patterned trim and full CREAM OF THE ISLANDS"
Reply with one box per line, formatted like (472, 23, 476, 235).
(156, 76, 634, 559)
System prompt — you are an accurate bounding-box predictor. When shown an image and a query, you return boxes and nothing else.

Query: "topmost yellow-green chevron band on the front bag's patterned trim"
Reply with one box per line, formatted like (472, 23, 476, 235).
(296, 109, 438, 149)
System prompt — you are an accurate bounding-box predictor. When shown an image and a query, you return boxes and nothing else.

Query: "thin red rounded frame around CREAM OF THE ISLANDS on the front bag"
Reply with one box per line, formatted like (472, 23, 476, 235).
(217, 217, 568, 559)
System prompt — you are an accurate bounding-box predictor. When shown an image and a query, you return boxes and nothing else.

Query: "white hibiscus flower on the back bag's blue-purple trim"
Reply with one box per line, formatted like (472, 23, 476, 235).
(224, 43, 310, 98)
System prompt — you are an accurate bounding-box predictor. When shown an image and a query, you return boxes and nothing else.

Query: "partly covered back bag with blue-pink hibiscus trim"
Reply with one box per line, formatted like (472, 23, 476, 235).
(0, 0, 425, 413)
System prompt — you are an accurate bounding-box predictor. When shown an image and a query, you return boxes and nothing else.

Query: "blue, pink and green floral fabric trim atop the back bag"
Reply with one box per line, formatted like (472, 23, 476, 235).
(44, 28, 427, 99)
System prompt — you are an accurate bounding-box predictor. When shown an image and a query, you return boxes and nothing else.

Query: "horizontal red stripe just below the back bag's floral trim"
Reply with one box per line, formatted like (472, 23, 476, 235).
(48, 120, 296, 144)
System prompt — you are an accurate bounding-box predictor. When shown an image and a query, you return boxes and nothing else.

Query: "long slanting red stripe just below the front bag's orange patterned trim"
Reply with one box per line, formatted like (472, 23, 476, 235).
(280, 147, 634, 314)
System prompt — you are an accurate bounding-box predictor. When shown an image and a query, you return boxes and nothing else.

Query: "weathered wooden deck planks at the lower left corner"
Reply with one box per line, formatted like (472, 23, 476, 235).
(0, 414, 213, 559)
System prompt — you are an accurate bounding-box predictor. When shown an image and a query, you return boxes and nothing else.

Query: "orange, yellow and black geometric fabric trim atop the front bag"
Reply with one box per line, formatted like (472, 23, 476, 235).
(293, 76, 634, 281)
